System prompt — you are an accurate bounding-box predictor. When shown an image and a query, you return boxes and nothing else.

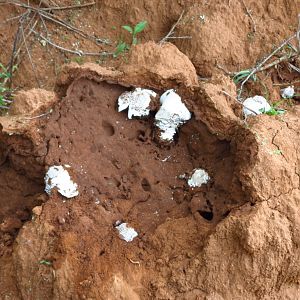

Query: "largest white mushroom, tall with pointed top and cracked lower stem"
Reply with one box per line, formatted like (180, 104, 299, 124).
(155, 89, 192, 141)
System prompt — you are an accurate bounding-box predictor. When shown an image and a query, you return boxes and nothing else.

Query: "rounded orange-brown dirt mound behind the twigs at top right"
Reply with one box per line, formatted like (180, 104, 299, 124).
(175, 0, 300, 77)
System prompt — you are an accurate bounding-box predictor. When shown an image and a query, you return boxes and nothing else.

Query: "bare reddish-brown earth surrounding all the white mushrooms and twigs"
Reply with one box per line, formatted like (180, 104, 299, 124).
(0, 1, 300, 300)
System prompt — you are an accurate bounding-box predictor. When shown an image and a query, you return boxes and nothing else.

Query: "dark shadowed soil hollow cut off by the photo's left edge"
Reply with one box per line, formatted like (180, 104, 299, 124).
(0, 146, 44, 248)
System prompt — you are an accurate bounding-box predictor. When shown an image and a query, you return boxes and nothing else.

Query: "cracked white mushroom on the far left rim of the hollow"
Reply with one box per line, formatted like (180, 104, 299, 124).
(45, 166, 79, 198)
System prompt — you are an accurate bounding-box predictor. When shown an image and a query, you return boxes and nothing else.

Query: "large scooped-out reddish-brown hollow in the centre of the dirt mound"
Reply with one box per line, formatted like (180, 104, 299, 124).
(35, 78, 247, 235)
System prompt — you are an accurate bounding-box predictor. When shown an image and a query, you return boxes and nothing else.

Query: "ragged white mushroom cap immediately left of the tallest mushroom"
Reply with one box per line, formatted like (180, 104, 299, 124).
(118, 88, 156, 119)
